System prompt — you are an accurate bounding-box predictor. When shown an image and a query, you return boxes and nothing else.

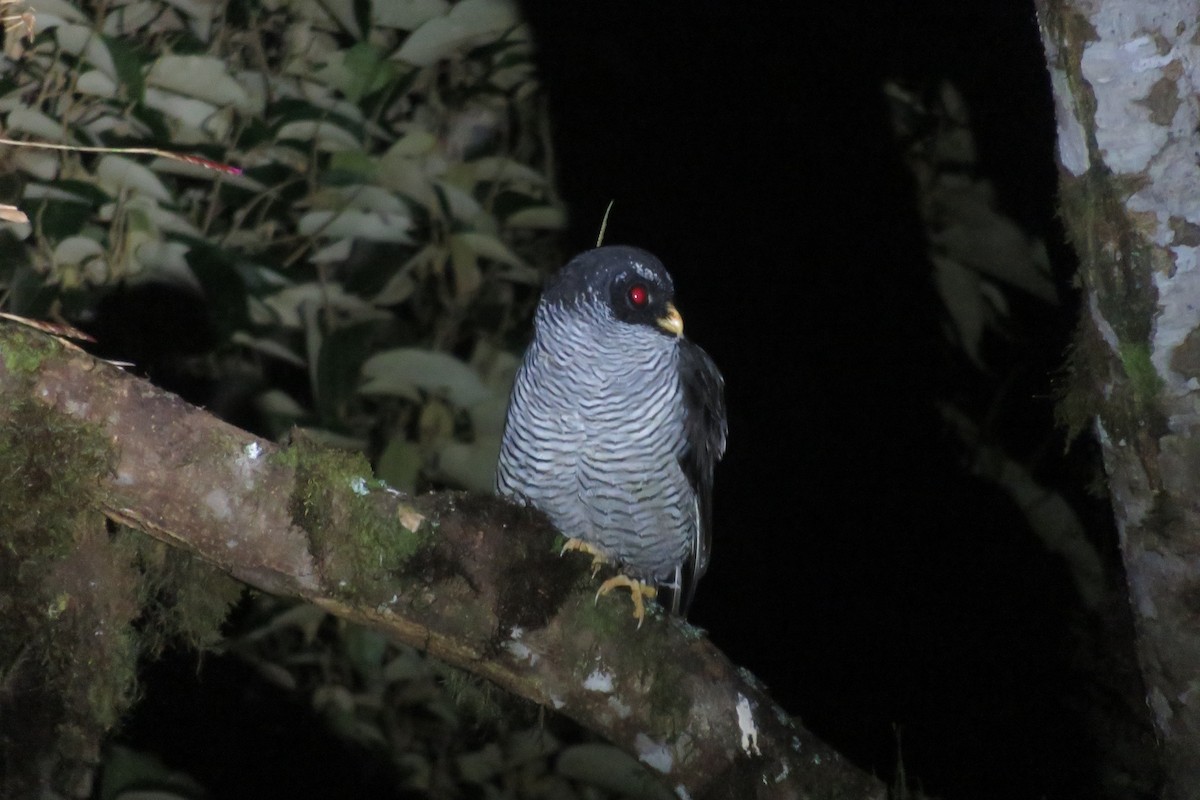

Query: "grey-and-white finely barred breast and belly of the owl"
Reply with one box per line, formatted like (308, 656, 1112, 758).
(497, 297, 698, 582)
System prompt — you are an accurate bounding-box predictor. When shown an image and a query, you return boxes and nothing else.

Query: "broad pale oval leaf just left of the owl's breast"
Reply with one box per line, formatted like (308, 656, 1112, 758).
(359, 348, 492, 408)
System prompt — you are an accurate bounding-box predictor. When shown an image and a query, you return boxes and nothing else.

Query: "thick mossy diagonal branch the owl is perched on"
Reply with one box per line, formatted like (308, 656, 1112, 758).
(0, 325, 886, 799)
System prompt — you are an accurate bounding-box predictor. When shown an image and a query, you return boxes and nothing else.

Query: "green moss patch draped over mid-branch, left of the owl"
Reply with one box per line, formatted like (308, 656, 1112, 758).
(272, 437, 430, 597)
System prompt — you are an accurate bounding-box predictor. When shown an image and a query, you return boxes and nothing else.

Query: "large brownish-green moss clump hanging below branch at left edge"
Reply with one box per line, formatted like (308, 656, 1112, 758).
(0, 395, 139, 792)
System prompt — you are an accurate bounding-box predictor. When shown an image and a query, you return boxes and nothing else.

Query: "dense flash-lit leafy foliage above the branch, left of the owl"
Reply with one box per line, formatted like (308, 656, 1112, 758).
(0, 0, 563, 489)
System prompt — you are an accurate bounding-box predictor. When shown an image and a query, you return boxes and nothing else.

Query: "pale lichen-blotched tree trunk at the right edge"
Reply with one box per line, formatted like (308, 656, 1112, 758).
(1038, 0, 1200, 799)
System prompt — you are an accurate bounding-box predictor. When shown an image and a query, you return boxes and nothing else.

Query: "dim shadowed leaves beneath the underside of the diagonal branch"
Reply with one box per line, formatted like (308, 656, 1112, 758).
(227, 596, 671, 800)
